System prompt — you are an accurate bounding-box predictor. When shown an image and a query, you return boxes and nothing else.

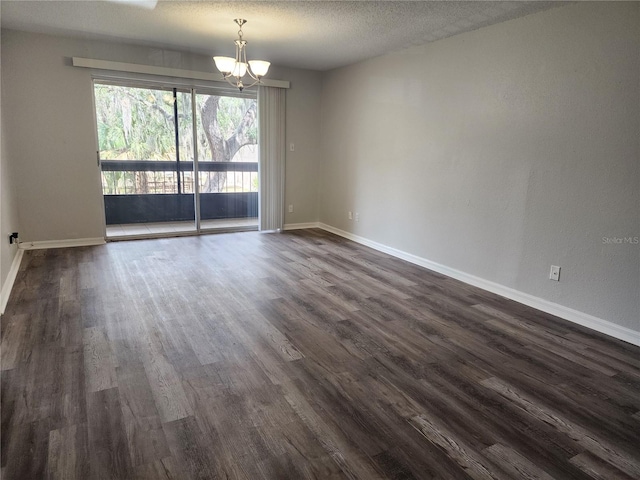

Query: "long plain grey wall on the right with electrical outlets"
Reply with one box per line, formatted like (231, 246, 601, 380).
(319, 2, 640, 331)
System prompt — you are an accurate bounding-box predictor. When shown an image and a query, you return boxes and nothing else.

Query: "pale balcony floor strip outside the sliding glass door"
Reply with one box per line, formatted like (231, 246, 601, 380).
(107, 217, 258, 240)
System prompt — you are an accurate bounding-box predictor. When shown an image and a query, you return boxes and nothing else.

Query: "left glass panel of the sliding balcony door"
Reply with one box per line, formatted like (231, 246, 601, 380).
(94, 83, 196, 237)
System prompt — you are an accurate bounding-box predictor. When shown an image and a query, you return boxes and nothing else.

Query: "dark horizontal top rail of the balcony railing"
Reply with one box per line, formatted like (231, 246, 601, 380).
(100, 160, 258, 172)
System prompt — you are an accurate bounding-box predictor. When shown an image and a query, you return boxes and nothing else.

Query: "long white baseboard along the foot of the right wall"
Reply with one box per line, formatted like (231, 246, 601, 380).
(318, 223, 640, 346)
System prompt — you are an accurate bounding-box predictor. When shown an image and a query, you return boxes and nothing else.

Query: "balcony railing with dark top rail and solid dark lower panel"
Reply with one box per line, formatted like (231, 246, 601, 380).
(101, 160, 258, 225)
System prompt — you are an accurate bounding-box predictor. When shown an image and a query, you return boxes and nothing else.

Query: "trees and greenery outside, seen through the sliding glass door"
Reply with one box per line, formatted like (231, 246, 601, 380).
(95, 84, 257, 194)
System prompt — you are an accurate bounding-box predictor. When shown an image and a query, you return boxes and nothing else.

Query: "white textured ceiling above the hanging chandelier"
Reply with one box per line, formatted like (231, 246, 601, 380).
(0, 0, 561, 70)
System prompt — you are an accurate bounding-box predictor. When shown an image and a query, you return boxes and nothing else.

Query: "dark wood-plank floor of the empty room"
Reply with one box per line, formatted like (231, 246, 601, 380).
(1, 230, 640, 480)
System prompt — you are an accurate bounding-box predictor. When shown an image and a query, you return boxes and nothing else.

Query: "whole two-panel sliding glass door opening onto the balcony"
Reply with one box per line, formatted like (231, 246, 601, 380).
(95, 82, 258, 238)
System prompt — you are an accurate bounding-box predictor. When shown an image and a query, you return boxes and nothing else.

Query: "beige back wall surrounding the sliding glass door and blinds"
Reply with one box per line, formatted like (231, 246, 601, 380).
(2, 30, 321, 242)
